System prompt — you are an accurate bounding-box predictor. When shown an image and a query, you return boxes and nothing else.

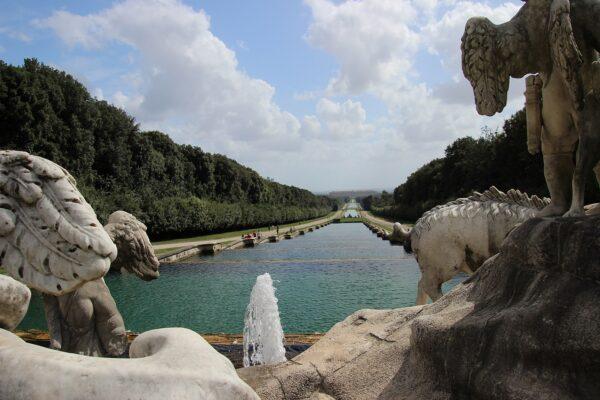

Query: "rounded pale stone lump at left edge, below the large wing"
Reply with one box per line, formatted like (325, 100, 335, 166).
(0, 275, 31, 331)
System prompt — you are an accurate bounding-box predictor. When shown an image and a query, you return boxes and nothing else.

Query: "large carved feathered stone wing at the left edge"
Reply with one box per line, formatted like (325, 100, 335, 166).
(0, 150, 117, 295)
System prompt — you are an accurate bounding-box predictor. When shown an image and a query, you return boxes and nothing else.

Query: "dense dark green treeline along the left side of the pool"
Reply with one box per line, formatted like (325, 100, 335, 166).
(0, 60, 334, 238)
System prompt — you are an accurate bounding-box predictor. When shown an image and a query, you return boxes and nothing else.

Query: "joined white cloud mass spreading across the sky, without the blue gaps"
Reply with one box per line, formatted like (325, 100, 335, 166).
(37, 0, 523, 189)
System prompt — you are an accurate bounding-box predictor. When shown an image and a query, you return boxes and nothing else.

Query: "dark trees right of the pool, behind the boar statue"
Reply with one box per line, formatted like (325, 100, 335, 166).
(370, 110, 600, 221)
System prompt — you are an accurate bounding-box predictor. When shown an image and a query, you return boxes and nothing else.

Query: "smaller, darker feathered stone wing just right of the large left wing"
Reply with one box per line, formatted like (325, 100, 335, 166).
(104, 211, 160, 281)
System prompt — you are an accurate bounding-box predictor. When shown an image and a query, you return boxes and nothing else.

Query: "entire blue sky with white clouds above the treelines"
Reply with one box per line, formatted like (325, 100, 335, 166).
(0, 0, 523, 191)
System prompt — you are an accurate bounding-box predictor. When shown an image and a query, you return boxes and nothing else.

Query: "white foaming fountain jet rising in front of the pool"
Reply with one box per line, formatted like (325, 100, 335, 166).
(244, 273, 286, 367)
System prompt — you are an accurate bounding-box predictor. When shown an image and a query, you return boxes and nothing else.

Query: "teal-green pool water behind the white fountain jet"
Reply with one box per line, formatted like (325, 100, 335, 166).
(20, 224, 464, 333)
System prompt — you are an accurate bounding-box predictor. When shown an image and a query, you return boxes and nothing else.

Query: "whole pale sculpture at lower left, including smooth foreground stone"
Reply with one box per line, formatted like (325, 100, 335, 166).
(0, 150, 258, 400)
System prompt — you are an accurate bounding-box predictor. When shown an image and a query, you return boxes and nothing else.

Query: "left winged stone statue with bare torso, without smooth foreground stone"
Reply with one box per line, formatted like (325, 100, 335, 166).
(0, 150, 159, 355)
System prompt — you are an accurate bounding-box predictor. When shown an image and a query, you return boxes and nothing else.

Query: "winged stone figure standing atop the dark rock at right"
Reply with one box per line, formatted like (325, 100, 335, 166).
(462, 0, 600, 217)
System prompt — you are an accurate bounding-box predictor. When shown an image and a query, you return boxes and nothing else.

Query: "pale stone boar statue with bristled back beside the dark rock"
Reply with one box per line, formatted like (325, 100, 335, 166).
(394, 186, 549, 305)
